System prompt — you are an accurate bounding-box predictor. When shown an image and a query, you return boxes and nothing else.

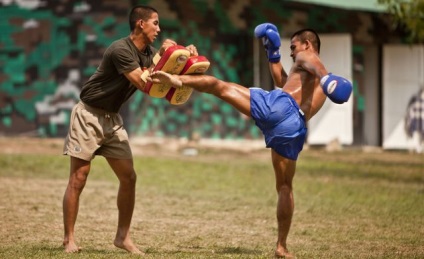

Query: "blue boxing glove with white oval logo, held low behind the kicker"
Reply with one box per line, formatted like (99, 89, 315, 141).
(321, 73, 352, 104)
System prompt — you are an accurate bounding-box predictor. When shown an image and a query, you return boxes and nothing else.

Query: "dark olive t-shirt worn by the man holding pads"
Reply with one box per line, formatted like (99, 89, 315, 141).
(80, 37, 157, 112)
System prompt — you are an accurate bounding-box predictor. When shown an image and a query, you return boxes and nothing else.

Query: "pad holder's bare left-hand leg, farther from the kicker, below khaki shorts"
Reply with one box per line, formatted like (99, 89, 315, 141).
(63, 157, 90, 253)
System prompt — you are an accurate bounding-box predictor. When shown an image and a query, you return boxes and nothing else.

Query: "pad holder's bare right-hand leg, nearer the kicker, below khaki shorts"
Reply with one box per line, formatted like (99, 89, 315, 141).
(107, 158, 143, 254)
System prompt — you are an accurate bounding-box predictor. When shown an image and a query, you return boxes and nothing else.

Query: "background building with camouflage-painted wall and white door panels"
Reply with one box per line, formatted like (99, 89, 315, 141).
(0, 0, 424, 149)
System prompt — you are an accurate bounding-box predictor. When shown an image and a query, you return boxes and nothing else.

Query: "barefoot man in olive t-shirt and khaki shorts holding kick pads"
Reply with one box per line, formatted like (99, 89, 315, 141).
(63, 5, 197, 254)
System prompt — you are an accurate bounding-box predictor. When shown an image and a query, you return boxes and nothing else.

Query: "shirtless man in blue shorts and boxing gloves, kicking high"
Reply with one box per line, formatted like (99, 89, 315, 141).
(148, 23, 352, 258)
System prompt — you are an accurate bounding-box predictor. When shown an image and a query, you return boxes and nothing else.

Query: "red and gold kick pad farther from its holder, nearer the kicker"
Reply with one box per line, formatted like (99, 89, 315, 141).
(166, 56, 210, 105)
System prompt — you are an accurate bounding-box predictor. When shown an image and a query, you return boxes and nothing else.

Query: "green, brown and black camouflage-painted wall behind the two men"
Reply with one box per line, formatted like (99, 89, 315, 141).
(0, 0, 399, 139)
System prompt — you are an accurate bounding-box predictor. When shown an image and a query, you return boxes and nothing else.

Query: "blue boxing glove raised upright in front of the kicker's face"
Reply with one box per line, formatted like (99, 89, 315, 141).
(255, 23, 281, 63)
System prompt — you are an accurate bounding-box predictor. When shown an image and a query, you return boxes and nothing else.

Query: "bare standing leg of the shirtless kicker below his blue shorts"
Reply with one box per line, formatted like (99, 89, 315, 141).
(272, 150, 296, 258)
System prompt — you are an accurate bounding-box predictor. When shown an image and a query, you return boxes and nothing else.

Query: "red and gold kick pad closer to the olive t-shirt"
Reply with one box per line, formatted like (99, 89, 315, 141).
(143, 45, 190, 98)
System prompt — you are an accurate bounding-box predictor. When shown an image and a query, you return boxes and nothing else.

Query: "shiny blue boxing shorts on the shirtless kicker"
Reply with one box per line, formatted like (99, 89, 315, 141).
(250, 87, 307, 160)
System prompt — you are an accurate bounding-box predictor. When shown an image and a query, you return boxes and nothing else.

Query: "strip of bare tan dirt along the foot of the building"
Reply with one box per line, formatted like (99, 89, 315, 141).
(0, 137, 423, 166)
